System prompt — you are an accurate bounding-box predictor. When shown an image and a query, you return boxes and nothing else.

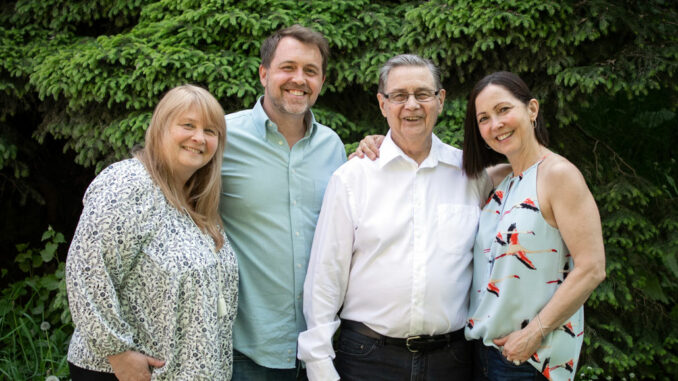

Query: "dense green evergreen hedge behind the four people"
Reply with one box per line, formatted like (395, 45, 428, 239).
(0, 0, 678, 380)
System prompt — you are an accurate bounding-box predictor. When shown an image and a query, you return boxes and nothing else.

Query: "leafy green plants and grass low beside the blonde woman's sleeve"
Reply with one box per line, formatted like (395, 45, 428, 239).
(0, 227, 73, 380)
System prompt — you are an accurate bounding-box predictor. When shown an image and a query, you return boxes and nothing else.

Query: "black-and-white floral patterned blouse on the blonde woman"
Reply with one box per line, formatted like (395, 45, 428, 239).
(66, 159, 238, 380)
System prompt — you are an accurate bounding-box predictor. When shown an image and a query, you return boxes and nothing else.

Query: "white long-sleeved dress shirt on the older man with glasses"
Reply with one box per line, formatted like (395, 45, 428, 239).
(299, 132, 491, 380)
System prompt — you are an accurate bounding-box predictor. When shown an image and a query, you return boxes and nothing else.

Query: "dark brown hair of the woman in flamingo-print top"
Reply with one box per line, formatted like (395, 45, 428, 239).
(463, 71, 549, 178)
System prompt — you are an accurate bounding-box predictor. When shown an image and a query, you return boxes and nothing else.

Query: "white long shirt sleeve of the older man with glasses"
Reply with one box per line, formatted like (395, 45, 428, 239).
(299, 173, 355, 381)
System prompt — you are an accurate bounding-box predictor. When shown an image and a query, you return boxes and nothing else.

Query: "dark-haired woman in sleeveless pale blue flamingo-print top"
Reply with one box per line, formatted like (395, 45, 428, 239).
(463, 72, 605, 380)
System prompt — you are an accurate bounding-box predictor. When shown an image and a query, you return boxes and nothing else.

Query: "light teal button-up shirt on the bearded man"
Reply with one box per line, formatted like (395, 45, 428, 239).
(219, 98, 346, 368)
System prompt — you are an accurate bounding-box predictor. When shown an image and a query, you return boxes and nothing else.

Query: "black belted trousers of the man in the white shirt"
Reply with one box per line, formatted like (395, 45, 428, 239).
(334, 325, 473, 381)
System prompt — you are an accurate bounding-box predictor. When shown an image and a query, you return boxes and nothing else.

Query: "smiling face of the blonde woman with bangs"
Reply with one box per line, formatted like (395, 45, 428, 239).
(162, 107, 219, 186)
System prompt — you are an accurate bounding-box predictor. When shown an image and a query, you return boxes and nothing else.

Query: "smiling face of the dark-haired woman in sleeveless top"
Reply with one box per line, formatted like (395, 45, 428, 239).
(475, 84, 539, 160)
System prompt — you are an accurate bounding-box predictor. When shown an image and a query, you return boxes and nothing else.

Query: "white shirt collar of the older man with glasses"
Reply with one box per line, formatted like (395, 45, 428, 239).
(379, 130, 462, 168)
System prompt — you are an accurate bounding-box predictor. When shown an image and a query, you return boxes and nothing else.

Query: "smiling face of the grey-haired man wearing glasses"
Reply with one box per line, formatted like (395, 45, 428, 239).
(377, 66, 445, 153)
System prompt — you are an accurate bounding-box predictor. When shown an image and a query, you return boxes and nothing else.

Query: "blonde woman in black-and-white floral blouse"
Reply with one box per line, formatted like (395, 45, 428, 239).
(66, 85, 238, 380)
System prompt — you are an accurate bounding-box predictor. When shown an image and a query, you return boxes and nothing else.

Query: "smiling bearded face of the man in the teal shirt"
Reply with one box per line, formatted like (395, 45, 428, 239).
(259, 37, 325, 123)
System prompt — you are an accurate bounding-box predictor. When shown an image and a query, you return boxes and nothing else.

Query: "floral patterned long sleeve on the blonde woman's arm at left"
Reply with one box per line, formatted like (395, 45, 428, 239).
(66, 162, 154, 358)
